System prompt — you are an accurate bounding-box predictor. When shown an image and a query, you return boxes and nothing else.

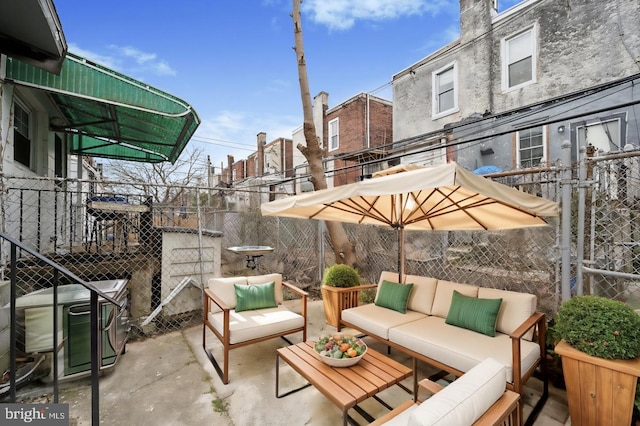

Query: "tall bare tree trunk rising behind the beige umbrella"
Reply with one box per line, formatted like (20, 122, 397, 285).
(292, 0, 356, 266)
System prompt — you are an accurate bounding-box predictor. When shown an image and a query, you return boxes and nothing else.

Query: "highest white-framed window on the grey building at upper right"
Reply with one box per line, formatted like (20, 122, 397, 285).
(502, 27, 536, 89)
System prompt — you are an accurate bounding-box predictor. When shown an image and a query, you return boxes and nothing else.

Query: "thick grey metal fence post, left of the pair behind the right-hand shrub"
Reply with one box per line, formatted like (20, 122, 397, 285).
(560, 141, 571, 303)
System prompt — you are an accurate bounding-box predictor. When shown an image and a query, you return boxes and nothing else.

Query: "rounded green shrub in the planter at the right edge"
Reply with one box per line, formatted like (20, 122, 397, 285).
(554, 296, 640, 359)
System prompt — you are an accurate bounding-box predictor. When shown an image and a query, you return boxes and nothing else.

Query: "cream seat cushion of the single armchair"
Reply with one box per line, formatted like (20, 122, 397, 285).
(208, 305, 304, 344)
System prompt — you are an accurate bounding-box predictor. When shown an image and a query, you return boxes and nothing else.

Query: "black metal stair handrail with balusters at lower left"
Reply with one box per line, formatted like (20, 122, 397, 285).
(0, 232, 123, 425)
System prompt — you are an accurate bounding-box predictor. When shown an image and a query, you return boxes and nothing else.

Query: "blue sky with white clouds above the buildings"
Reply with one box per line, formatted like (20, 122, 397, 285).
(55, 0, 520, 170)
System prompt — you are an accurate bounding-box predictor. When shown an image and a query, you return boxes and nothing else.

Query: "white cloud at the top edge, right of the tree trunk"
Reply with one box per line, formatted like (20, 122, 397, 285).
(302, 0, 458, 30)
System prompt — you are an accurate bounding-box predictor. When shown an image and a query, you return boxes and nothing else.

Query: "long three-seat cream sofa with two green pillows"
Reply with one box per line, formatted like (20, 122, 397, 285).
(340, 271, 548, 421)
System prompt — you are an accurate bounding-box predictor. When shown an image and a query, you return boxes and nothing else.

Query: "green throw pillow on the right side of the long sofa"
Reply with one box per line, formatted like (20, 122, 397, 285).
(445, 290, 502, 337)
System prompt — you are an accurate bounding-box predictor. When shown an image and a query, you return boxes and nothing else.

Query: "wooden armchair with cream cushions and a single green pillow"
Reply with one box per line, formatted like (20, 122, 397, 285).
(202, 274, 308, 384)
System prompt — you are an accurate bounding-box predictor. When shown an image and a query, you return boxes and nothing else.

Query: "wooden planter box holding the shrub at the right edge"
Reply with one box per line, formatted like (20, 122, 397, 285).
(555, 340, 640, 426)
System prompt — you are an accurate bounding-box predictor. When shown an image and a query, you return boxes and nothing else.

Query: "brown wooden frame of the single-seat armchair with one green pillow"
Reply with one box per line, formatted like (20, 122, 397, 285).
(202, 281, 308, 385)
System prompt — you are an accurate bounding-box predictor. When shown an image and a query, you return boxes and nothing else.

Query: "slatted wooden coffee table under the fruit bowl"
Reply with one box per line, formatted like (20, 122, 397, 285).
(276, 342, 413, 425)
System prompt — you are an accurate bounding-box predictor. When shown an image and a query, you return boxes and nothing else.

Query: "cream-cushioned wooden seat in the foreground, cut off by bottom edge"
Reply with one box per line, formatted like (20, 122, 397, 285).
(370, 358, 520, 426)
